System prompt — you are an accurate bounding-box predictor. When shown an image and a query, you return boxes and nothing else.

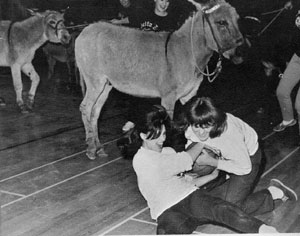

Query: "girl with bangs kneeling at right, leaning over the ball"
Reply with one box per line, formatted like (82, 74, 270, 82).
(184, 96, 296, 215)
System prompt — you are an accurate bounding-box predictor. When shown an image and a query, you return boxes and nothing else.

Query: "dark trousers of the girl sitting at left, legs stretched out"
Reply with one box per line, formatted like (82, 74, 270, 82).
(157, 189, 263, 234)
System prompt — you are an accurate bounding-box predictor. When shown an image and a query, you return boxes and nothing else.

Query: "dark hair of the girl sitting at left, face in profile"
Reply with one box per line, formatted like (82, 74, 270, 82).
(139, 105, 170, 139)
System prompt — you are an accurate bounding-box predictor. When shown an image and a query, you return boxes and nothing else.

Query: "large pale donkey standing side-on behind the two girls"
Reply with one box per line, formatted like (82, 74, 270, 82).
(75, 0, 243, 160)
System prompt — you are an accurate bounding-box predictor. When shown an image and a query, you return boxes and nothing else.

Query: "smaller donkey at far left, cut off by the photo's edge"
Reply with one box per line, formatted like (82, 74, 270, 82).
(0, 10, 70, 113)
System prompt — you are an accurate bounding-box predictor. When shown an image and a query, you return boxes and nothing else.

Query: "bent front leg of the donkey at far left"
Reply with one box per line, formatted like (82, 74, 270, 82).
(22, 63, 40, 111)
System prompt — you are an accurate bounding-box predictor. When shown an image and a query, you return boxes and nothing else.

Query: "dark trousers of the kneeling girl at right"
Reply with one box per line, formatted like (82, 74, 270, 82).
(209, 149, 274, 215)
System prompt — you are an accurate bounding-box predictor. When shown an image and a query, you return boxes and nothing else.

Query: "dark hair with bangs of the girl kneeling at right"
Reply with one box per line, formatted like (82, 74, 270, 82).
(183, 96, 227, 138)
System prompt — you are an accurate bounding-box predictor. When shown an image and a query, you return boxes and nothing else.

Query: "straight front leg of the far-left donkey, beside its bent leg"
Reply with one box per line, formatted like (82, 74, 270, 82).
(11, 65, 28, 113)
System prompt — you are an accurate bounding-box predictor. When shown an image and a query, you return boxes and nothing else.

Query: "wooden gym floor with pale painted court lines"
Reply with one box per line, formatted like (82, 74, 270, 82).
(0, 55, 300, 236)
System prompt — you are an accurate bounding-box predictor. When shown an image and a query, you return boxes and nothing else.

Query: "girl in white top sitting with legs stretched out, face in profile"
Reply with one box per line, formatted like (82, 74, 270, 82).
(133, 105, 296, 234)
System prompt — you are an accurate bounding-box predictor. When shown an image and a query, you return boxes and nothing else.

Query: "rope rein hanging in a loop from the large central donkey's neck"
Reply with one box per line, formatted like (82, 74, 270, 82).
(190, 11, 223, 83)
